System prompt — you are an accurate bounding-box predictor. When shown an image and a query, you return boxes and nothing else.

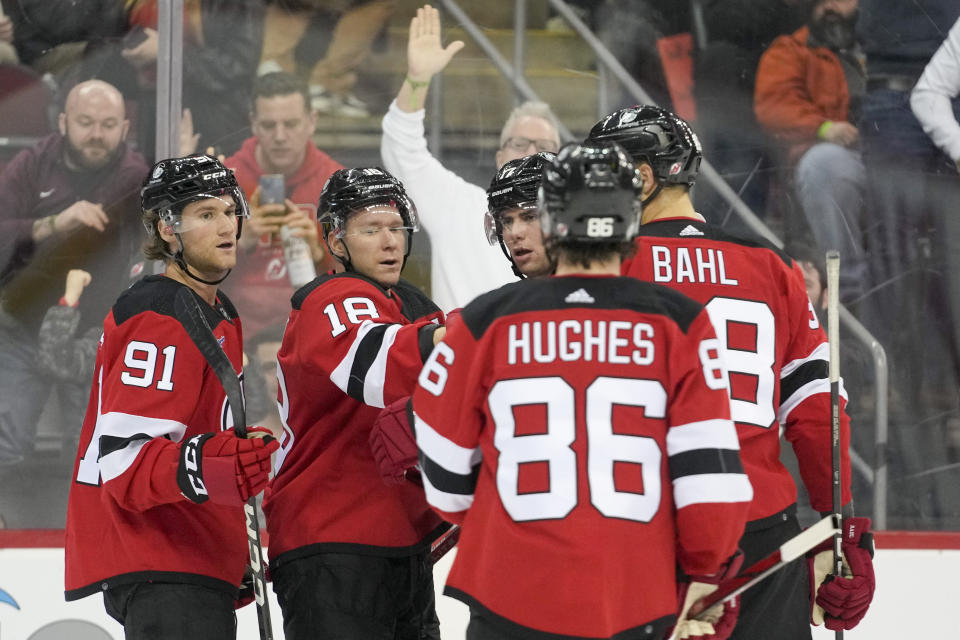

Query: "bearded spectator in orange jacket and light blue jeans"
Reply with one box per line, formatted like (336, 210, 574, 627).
(754, 0, 867, 303)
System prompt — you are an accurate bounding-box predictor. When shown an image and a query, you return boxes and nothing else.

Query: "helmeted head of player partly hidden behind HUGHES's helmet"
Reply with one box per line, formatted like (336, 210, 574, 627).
(484, 151, 556, 278)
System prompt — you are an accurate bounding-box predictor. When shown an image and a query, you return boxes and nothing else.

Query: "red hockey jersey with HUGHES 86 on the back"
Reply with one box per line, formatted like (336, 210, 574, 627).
(413, 276, 752, 638)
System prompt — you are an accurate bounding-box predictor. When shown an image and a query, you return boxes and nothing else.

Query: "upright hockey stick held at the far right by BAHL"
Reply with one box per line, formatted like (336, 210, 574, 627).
(827, 249, 843, 640)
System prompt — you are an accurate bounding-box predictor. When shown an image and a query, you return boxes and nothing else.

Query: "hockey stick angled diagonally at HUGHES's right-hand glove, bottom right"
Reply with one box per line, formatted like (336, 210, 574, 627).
(687, 515, 840, 619)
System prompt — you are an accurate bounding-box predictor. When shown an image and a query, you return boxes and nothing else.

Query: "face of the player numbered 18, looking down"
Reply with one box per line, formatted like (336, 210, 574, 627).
(342, 205, 407, 287)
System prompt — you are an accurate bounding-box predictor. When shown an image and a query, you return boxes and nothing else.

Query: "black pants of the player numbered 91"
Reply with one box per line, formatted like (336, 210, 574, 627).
(103, 582, 237, 640)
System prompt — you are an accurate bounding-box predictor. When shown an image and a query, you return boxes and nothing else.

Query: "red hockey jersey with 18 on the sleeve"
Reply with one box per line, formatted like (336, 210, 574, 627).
(263, 273, 443, 567)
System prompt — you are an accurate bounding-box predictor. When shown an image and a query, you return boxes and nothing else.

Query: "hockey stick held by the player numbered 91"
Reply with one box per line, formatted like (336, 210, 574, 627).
(174, 286, 273, 640)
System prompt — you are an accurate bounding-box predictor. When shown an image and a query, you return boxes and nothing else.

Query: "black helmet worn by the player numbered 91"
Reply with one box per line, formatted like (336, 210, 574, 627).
(140, 153, 250, 238)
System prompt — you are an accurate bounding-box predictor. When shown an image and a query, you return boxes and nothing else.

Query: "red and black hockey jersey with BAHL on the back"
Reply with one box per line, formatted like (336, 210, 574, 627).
(622, 218, 850, 521)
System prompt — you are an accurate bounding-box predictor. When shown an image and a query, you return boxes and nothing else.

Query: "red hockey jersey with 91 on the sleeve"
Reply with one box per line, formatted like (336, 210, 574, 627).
(65, 276, 248, 600)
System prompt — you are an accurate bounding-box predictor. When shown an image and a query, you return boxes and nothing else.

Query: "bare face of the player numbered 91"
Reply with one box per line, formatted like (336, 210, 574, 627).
(180, 195, 237, 280)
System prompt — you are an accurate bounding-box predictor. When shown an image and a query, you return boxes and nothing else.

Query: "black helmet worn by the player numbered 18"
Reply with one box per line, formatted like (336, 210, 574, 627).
(317, 167, 420, 257)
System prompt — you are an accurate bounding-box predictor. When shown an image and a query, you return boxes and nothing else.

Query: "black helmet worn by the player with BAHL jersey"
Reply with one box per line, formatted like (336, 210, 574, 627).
(587, 105, 703, 188)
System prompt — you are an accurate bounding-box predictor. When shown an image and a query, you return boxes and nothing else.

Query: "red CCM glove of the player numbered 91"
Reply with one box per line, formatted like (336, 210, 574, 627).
(177, 427, 280, 507)
